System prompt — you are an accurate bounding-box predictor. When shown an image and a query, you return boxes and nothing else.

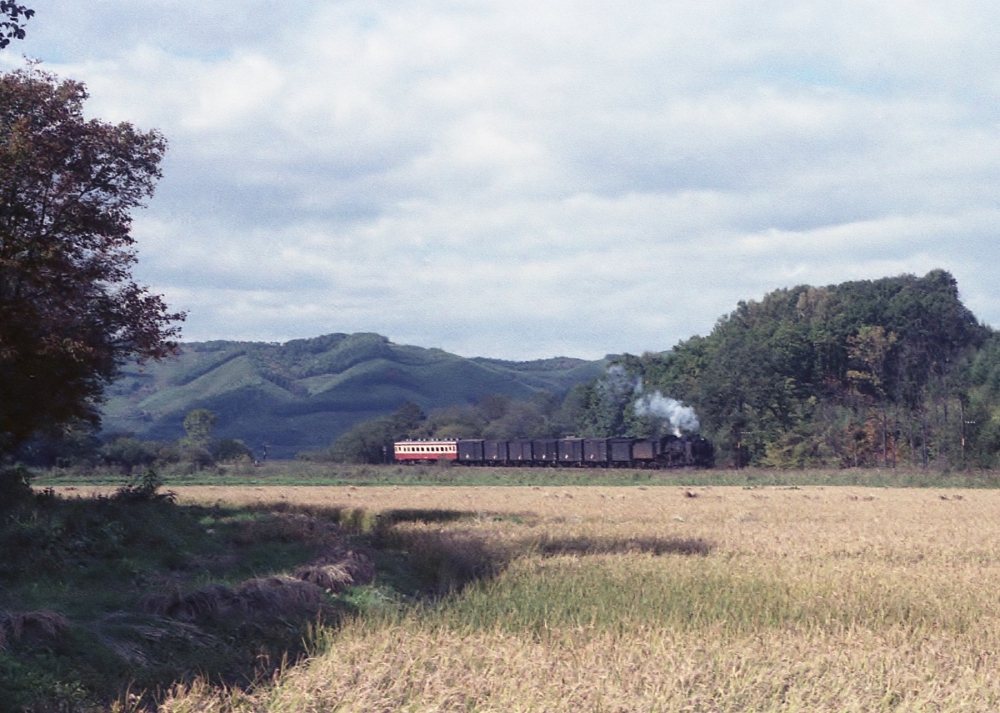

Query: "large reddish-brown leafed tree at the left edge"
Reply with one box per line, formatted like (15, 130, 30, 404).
(0, 67, 184, 454)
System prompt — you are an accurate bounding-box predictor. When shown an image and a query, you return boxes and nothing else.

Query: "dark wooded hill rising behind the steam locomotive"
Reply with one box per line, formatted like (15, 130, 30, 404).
(580, 270, 1000, 467)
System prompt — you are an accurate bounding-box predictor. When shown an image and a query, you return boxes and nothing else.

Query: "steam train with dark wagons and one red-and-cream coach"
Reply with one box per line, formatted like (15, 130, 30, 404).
(393, 436, 715, 468)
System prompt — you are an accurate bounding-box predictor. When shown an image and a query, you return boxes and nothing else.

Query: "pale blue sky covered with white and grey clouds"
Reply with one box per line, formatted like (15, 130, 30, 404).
(0, 0, 1000, 359)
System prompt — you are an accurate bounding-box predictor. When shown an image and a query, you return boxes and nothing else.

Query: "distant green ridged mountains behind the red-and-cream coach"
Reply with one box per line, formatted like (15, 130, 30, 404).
(102, 333, 605, 458)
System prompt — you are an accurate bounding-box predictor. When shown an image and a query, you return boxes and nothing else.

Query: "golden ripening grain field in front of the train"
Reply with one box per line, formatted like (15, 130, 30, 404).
(119, 487, 1000, 713)
